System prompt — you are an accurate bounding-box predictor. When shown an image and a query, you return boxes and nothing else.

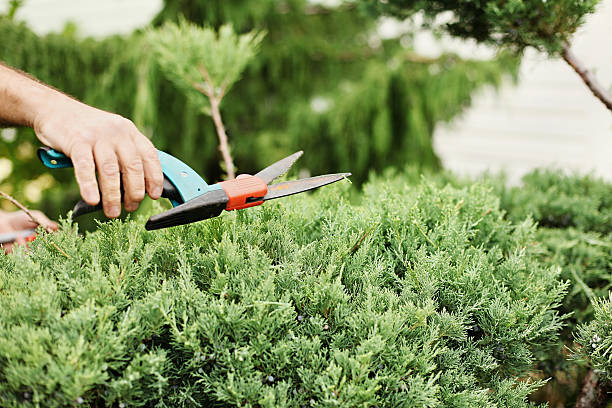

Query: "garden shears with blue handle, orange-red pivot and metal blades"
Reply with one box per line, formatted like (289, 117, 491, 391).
(38, 147, 351, 230)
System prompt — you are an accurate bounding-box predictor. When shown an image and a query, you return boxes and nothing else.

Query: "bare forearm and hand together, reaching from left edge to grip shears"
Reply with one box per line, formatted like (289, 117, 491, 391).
(0, 64, 163, 218)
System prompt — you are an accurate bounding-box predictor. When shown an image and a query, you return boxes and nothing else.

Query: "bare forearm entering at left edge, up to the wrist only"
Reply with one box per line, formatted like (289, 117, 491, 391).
(0, 63, 68, 127)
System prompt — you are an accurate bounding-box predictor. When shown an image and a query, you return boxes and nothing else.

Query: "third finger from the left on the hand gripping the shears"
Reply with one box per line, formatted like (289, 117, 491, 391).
(117, 143, 145, 211)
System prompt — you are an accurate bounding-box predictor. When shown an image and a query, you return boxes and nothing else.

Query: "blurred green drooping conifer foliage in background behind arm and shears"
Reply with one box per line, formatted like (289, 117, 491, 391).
(0, 0, 517, 216)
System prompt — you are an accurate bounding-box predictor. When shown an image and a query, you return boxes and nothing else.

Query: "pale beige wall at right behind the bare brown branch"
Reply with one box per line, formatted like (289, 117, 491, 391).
(434, 0, 612, 182)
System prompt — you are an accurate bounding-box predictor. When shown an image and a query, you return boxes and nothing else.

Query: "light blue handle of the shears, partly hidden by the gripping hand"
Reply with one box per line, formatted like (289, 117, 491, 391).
(38, 147, 221, 207)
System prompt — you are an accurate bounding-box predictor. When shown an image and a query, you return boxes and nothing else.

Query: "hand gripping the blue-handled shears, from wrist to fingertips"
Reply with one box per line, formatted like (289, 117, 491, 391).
(33, 94, 163, 218)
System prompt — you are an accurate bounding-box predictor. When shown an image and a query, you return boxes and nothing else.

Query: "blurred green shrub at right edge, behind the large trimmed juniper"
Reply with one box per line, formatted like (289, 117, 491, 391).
(492, 170, 612, 336)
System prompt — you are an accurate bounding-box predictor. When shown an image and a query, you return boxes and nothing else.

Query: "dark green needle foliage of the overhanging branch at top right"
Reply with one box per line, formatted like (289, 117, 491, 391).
(358, 0, 599, 53)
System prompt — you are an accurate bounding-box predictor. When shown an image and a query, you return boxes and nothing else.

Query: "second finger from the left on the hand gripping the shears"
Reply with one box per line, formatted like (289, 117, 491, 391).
(94, 142, 121, 218)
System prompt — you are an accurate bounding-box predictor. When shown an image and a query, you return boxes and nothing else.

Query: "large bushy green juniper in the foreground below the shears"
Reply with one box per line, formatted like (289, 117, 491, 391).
(0, 178, 566, 407)
